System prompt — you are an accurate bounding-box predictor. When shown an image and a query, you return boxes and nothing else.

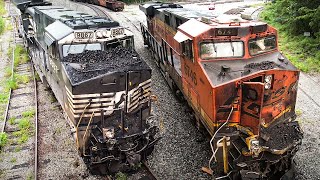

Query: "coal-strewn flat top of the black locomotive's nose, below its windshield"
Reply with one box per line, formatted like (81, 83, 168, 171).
(62, 46, 149, 84)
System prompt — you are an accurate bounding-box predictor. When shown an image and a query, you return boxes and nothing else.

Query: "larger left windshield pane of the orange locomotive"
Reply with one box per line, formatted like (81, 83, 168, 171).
(200, 41, 244, 60)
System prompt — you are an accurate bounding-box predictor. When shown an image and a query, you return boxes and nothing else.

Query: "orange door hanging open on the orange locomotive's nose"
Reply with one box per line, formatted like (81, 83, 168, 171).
(240, 82, 264, 135)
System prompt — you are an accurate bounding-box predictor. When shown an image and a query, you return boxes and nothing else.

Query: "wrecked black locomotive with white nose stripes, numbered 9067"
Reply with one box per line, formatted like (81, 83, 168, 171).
(14, 0, 158, 174)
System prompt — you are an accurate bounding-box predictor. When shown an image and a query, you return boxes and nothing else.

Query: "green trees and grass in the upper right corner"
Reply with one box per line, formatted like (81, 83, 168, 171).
(261, 0, 320, 72)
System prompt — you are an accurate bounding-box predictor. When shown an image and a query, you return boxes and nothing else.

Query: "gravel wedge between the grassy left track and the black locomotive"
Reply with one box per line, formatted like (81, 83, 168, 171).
(38, 83, 99, 179)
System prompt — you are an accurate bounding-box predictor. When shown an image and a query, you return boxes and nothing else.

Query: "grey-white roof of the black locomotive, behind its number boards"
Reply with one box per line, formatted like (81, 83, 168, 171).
(29, 6, 119, 29)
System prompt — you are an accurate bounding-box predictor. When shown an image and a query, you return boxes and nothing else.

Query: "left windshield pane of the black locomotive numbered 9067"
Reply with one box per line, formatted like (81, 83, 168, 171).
(62, 43, 101, 57)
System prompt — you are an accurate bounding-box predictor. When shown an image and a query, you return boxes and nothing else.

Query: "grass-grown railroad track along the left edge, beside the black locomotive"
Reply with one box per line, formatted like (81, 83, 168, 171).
(0, 5, 38, 179)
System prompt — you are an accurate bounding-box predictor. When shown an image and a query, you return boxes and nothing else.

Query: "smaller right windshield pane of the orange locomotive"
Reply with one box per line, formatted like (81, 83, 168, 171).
(249, 36, 276, 56)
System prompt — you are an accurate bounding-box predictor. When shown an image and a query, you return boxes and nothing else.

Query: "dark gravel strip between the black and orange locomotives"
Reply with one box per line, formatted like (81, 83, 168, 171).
(110, 8, 211, 179)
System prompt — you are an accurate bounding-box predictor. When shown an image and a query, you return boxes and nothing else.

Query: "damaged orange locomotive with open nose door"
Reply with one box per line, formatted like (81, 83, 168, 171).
(140, 3, 302, 179)
